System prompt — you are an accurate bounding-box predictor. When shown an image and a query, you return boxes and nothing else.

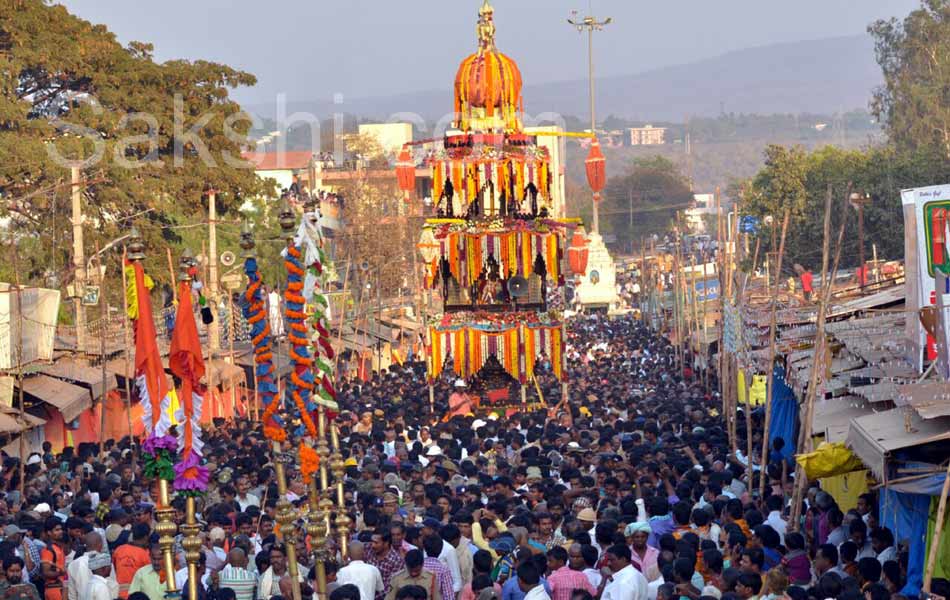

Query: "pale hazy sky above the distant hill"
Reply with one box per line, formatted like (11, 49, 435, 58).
(61, 0, 919, 103)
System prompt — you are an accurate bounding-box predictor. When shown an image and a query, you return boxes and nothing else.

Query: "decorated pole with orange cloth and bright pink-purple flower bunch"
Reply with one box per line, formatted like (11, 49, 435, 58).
(168, 257, 208, 599)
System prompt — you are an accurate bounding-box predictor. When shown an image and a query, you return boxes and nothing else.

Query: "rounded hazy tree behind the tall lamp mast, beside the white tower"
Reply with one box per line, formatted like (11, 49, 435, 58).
(600, 156, 693, 247)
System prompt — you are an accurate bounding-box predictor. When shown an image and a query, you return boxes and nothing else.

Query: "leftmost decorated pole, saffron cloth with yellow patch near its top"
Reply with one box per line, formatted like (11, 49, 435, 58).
(125, 227, 178, 596)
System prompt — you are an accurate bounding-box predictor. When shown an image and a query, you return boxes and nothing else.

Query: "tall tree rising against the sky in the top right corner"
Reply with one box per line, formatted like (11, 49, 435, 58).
(868, 0, 950, 159)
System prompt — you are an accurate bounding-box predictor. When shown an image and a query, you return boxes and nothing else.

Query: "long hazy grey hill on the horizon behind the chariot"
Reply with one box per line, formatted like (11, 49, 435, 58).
(247, 35, 881, 121)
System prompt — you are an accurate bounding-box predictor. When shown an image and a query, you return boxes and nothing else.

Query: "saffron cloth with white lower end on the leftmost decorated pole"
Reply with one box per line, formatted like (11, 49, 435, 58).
(129, 262, 171, 438)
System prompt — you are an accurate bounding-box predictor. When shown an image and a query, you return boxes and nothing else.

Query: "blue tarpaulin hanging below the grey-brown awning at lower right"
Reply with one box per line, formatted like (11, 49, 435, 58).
(880, 488, 930, 598)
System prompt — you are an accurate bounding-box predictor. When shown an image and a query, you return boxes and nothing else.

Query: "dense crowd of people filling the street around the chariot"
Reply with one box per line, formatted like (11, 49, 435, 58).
(0, 315, 947, 600)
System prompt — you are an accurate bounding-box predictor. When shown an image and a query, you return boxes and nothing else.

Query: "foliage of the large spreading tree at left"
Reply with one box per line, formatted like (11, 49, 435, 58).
(0, 0, 265, 300)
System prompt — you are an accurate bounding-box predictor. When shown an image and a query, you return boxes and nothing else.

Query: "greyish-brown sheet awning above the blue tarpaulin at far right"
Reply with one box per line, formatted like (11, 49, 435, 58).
(847, 408, 950, 481)
